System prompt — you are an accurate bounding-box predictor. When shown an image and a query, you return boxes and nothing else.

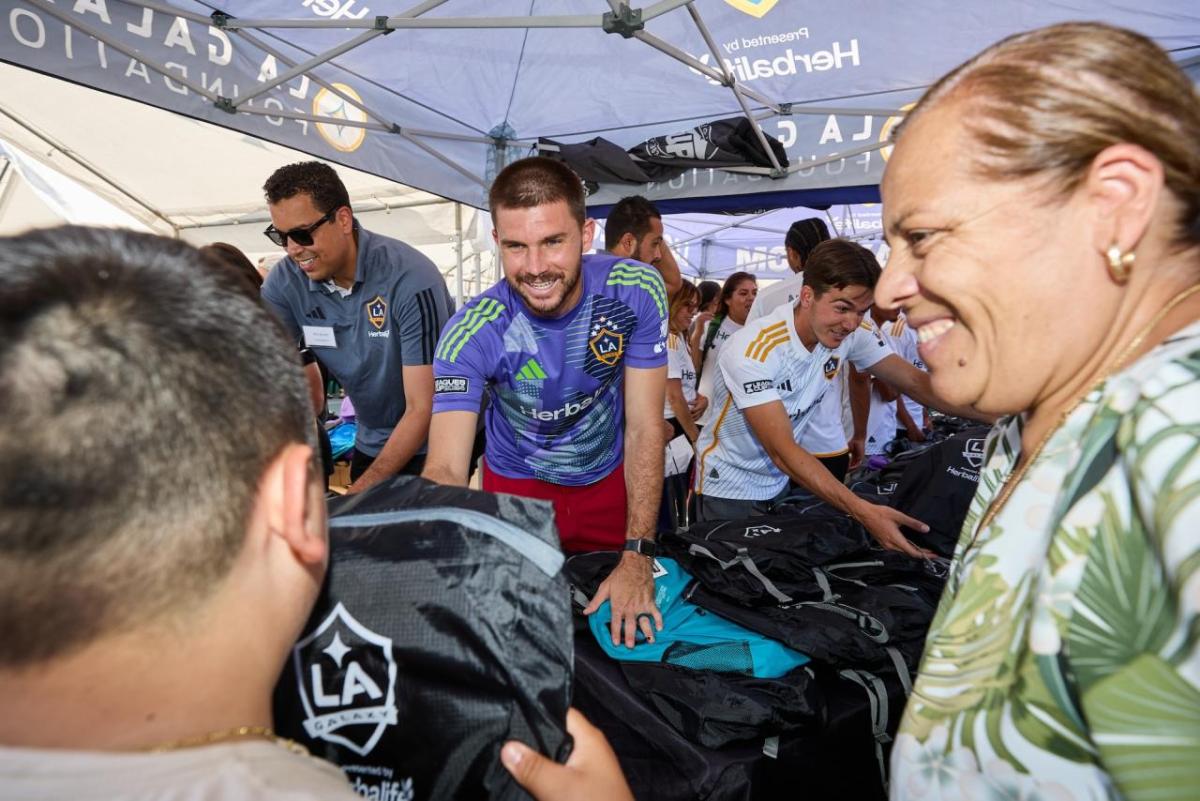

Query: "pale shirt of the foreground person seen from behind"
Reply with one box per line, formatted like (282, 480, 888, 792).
(0, 740, 361, 801)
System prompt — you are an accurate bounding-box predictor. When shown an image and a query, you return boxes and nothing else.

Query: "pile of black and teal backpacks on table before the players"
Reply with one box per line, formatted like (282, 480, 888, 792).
(565, 418, 988, 800)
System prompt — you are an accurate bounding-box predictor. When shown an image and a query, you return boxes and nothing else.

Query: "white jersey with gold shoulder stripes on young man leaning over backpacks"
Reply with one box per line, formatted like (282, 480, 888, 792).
(696, 306, 892, 500)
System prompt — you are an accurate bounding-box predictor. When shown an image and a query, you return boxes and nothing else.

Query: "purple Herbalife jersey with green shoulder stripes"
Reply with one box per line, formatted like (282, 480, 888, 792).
(433, 255, 667, 487)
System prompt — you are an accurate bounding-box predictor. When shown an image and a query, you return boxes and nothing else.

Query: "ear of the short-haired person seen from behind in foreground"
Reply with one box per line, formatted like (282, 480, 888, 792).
(259, 442, 329, 566)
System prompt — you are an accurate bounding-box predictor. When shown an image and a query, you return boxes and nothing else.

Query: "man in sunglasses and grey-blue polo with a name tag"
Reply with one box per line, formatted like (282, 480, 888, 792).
(263, 162, 452, 493)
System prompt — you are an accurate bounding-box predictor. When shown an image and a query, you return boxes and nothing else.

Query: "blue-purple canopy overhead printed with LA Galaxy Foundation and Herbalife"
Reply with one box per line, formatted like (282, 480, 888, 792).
(0, 0, 1200, 210)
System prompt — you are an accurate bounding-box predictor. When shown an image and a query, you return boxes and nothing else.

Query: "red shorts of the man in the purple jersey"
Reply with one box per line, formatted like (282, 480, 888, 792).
(484, 459, 625, 553)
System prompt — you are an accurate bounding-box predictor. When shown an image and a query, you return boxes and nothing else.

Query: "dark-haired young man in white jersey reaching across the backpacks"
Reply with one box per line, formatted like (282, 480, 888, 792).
(695, 240, 978, 556)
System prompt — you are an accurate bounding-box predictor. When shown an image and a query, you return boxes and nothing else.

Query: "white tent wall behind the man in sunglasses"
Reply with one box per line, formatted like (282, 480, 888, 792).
(0, 64, 493, 303)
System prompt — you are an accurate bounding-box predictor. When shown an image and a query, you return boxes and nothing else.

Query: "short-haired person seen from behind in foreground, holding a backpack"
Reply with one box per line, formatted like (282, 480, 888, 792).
(0, 228, 629, 801)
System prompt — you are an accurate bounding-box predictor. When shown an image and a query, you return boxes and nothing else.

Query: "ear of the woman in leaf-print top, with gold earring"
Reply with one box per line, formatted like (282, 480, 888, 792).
(1084, 143, 1164, 254)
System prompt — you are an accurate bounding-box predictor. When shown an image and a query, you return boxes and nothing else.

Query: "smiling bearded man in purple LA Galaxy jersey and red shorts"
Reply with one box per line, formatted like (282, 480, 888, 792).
(422, 157, 667, 646)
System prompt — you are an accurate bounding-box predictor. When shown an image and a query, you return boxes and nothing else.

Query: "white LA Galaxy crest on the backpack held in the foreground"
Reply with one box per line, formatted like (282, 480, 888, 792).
(292, 603, 397, 757)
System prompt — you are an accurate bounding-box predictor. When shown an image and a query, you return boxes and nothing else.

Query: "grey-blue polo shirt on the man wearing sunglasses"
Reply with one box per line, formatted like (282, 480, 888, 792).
(263, 228, 454, 456)
